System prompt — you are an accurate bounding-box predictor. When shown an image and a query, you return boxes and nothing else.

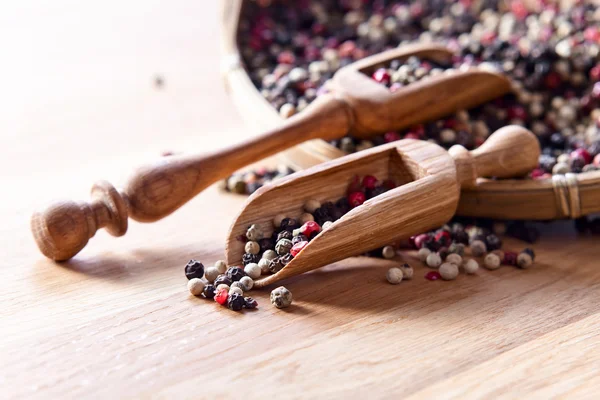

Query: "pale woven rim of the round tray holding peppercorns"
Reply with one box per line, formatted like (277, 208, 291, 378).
(221, 0, 600, 220)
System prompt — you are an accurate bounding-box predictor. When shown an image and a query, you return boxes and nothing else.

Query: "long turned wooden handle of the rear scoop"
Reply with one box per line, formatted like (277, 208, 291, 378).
(31, 95, 352, 261)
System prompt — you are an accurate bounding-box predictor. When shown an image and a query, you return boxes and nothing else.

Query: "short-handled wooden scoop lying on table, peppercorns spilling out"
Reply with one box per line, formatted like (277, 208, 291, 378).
(227, 126, 540, 287)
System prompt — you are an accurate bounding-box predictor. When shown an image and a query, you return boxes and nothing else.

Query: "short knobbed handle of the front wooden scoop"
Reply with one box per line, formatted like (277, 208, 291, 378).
(448, 125, 541, 188)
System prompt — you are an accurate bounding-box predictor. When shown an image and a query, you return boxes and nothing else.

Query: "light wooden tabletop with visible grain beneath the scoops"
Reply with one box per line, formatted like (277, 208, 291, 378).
(0, 0, 600, 399)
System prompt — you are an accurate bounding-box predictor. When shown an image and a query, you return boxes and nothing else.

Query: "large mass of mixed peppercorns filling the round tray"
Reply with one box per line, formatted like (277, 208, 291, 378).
(239, 0, 600, 175)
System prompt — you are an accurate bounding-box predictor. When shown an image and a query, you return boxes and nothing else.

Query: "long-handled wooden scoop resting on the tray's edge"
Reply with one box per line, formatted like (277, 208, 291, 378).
(31, 45, 511, 261)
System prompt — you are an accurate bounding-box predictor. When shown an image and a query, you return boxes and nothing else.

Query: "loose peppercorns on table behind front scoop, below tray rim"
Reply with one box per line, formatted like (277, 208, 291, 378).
(411, 223, 535, 280)
